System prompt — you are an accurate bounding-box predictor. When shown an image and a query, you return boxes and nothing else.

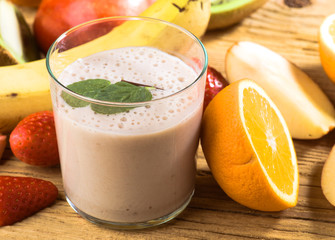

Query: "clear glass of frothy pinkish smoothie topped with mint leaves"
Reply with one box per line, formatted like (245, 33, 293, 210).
(46, 17, 207, 229)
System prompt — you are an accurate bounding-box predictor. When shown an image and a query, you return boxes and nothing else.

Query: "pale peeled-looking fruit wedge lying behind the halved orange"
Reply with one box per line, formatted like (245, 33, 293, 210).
(226, 41, 335, 139)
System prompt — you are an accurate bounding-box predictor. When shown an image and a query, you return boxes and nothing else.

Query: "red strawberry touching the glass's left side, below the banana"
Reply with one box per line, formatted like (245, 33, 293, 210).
(9, 111, 59, 166)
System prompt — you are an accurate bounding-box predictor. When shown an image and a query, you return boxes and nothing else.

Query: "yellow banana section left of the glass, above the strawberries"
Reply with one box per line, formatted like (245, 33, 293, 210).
(0, 60, 52, 134)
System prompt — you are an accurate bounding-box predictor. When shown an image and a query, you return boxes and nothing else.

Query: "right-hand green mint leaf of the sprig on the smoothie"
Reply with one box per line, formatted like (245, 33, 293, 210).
(91, 82, 152, 114)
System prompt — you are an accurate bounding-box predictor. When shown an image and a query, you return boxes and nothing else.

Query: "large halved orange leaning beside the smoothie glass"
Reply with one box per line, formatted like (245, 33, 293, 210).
(201, 79, 299, 211)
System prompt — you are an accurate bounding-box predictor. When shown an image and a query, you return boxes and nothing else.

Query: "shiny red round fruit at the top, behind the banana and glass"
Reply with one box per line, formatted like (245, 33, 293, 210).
(33, 0, 156, 53)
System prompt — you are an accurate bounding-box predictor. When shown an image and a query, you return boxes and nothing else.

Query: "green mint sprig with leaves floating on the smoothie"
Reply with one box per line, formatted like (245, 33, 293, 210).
(61, 79, 153, 115)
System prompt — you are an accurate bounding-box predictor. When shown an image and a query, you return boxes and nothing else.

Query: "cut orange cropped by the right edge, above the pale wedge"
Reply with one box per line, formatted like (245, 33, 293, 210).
(319, 14, 335, 82)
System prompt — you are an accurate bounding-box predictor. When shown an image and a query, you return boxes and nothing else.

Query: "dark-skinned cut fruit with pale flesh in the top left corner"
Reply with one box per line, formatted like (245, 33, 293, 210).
(0, 0, 40, 66)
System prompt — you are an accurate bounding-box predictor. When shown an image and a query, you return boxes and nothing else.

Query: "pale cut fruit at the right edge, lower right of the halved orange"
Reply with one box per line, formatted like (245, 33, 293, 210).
(321, 146, 335, 206)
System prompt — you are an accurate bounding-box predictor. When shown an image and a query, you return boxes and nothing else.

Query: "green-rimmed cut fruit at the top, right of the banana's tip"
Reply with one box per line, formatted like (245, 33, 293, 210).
(208, 0, 267, 30)
